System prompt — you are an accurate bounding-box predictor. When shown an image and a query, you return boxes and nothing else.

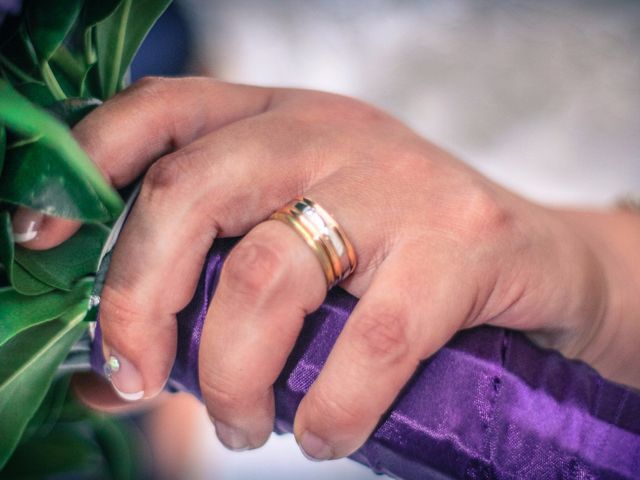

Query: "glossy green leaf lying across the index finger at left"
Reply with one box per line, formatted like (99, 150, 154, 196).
(0, 80, 122, 222)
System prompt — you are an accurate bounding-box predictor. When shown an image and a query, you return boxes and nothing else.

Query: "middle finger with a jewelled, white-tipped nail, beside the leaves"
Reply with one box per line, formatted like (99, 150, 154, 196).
(100, 117, 318, 400)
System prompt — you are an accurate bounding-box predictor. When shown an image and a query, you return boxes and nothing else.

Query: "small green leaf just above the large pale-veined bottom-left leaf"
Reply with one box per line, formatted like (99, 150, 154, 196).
(0, 279, 93, 346)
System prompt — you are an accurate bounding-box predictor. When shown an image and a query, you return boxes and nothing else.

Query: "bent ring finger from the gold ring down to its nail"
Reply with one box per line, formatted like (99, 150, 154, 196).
(199, 221, 326, 450)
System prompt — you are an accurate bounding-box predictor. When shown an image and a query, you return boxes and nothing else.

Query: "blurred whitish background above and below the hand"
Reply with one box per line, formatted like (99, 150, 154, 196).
(133, 0, 640, 480)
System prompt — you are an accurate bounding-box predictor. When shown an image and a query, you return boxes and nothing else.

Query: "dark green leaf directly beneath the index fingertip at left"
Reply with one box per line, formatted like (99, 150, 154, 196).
(15, 224, 109, 291)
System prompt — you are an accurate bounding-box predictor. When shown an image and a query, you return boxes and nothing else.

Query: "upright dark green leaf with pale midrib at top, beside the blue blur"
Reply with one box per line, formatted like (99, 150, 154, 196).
(96, 0, 171, 98)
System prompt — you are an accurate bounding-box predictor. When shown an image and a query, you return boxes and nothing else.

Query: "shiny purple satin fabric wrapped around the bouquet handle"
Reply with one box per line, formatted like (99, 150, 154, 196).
(92, 239, 640, 479)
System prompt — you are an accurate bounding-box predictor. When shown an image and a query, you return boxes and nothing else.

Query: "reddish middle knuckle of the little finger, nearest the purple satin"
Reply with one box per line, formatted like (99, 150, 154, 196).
(352, 306, 409, 363)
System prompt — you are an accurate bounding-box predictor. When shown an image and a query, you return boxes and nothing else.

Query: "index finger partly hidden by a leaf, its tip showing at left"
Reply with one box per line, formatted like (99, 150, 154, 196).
(13, 78, 273, 249)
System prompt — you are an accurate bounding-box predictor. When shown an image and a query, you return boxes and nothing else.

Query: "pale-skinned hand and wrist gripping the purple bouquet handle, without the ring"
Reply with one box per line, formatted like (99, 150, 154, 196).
(14, 78, 640, 459)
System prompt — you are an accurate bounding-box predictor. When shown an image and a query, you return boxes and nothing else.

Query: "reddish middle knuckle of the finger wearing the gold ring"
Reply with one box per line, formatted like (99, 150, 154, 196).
(225, 239, 287, 297)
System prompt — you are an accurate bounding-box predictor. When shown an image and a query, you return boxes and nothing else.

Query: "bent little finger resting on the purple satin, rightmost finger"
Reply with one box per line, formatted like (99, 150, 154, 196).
(294, 249, 472, 460)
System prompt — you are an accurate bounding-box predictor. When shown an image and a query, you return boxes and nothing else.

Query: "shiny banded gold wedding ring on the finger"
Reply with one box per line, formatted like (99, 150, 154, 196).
(271, 197, 357, 289)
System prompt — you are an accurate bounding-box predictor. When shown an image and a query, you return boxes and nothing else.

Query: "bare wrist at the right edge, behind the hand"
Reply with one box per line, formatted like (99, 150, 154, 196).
(557, 206, 640, 388)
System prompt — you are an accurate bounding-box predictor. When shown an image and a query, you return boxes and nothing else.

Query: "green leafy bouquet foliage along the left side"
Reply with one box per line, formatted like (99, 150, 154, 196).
(0, 0, 170, 472)
